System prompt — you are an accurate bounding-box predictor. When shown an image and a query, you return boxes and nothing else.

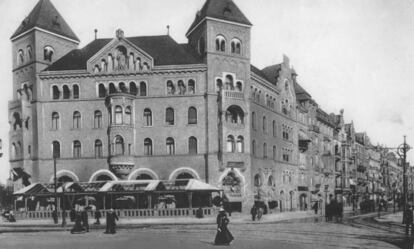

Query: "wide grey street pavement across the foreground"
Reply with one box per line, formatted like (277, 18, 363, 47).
(0, 214, 412, 249)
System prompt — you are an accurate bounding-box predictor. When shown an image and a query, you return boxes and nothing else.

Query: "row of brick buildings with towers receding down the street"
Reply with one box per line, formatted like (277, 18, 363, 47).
(9, 0, 408, 211)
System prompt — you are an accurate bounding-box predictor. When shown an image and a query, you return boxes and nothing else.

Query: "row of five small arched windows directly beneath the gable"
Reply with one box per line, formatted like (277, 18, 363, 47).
(97, 81, 148, 98)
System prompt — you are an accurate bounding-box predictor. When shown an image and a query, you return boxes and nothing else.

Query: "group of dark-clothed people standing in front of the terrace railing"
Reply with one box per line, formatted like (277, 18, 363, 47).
(70, 206, 119, 234)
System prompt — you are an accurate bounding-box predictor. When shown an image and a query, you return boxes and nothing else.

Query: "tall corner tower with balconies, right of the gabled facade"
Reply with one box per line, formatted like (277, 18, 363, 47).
(186, 0, 253, 211)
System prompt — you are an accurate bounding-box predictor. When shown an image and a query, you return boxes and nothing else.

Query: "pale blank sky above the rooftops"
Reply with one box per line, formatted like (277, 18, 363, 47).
(0, 0, 414, 182)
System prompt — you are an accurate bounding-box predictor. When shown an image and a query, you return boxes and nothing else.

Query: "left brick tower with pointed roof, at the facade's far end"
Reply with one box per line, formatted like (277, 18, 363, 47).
(9, 0, 79, 184)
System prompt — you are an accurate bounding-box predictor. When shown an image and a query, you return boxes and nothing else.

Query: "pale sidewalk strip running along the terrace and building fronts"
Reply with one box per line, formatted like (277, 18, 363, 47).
(0, 211, 321, 233)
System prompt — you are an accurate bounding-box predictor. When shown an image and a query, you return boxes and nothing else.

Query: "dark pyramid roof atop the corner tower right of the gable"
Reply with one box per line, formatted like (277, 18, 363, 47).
(187, 0, 252, 34)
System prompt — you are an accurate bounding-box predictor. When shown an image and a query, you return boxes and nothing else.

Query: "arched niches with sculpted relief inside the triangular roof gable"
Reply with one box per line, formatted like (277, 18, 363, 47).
(93, 46, 151, 73)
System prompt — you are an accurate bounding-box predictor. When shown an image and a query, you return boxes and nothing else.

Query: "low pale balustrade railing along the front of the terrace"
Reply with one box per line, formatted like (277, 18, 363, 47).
(15, 208, 216, 220)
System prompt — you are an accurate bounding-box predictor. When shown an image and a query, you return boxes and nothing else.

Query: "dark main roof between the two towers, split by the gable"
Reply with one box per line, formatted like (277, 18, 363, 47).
(46, 35, 203, 71)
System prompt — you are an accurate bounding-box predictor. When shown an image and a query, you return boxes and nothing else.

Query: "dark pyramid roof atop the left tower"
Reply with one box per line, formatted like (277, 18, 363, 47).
(10, 0, 79, 42)
